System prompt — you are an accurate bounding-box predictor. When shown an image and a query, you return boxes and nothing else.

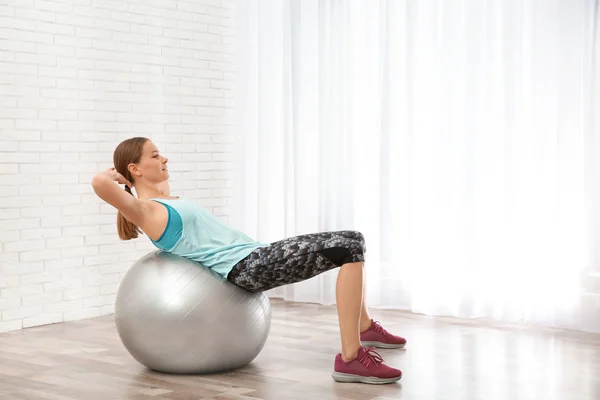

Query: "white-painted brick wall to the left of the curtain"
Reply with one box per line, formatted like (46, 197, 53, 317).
(0, 0, 235, 332)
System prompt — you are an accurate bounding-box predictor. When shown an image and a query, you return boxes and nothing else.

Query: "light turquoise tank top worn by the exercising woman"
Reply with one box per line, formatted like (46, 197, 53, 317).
(149, 198, 268, 279)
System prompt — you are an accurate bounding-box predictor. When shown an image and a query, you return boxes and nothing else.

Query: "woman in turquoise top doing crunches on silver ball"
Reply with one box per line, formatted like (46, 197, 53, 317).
(92, 137, 406, 383)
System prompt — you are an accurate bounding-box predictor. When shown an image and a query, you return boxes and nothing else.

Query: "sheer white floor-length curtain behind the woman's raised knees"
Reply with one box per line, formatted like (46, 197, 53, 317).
(233, 0, 600, 329)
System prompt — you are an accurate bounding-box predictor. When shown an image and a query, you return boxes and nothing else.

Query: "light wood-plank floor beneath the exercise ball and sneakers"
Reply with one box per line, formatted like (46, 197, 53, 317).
(0, 300, 600, 400)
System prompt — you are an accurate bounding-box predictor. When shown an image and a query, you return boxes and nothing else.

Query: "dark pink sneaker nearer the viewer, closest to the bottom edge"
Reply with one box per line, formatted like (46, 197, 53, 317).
(331, 347, 402, 384)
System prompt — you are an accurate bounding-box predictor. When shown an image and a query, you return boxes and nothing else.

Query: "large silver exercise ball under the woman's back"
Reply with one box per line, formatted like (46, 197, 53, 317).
(115, 251, 271, 374)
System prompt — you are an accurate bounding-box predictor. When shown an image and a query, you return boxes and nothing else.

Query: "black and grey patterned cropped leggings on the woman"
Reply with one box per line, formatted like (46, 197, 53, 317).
(227, 231, 366, 292)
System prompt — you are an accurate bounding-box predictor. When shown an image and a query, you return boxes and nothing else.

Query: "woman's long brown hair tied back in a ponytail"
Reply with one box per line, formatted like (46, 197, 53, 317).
(113, 137, 149, 240)
